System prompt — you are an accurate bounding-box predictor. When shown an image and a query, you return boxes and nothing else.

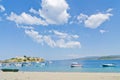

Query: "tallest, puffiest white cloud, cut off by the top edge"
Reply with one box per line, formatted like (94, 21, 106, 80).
(39, 0, 70, 24)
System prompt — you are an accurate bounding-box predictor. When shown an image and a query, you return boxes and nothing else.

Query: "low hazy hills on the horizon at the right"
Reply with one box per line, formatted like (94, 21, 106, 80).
(73, 55, 120, 60)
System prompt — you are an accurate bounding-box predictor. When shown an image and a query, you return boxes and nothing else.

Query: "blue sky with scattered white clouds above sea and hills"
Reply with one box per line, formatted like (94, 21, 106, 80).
(0, 0, 120, 60)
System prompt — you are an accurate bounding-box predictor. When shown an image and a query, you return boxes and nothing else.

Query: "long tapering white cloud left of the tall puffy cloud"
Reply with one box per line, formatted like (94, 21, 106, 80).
(7, 12, 47, 25)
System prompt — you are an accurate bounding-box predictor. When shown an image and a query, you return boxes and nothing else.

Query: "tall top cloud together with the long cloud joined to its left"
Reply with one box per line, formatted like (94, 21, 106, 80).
(6, 0, 70, 26)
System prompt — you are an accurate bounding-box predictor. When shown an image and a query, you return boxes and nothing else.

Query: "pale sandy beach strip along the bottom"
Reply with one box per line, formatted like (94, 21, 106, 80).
(0, 72, 120, 80)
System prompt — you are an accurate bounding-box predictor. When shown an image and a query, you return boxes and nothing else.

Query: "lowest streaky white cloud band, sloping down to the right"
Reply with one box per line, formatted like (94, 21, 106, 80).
(25, 30, 81, 48)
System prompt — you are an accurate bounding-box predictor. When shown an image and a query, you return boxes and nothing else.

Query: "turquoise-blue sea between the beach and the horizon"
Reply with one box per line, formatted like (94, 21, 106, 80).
(0, 60, 120, 73)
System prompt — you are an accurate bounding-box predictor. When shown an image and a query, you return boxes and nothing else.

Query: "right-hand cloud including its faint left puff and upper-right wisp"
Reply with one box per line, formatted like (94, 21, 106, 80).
(77, 8, 113, 29)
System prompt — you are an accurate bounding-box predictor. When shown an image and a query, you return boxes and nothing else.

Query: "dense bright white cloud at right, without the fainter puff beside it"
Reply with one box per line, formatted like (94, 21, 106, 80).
(84, 13, 112, 29)
